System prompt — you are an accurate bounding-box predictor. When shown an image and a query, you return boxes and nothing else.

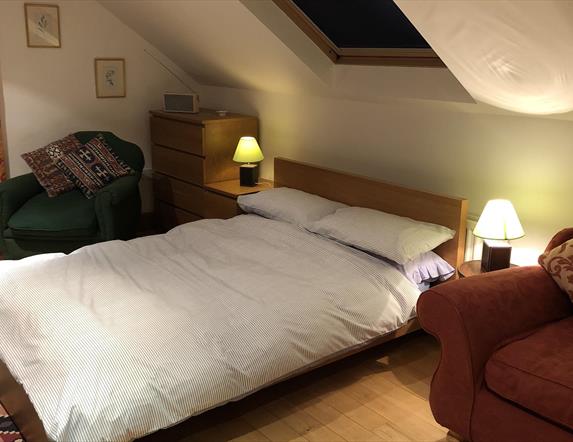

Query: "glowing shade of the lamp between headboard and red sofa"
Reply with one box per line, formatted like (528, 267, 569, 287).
(474, 199, 525, 240)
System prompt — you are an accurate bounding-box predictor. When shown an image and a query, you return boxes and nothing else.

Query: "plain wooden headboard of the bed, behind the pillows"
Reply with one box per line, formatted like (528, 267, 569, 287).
(274, 158, 468, 268)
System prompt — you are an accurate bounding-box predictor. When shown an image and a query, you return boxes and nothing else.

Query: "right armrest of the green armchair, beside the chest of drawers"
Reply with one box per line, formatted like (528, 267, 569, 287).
(95, 174, 141, 241)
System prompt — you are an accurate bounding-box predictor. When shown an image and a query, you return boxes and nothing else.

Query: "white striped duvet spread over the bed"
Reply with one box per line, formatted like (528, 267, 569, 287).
(0, 215, 419, 442)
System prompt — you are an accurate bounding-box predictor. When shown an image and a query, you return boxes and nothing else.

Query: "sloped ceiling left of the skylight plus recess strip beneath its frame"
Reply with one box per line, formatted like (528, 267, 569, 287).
(100, 0, 473, 103)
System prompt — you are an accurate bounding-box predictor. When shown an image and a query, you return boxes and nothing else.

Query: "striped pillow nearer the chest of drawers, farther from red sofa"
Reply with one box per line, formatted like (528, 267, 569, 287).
(238, 187, 348, 227)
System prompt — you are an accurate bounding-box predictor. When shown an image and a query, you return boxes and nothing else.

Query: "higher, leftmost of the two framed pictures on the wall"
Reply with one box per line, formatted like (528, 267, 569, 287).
(24, 3, 62, 48)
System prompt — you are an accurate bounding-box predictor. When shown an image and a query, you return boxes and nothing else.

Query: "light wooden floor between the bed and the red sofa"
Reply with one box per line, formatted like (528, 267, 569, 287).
(143, 332, 446, 442)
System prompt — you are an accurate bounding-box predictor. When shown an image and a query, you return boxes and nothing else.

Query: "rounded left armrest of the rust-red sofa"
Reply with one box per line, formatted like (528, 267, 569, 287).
(418, 267, 573, 439)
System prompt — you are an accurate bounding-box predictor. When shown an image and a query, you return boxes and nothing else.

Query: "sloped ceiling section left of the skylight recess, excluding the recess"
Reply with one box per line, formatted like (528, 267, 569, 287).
(102, 0, 326, 92)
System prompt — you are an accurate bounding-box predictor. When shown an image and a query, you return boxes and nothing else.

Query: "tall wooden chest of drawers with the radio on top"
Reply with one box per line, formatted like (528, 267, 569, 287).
(150, 110, 259, 230)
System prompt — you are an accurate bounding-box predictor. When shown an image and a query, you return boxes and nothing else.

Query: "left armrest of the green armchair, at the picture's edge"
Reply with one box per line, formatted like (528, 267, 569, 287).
(0, 173, 44, 231)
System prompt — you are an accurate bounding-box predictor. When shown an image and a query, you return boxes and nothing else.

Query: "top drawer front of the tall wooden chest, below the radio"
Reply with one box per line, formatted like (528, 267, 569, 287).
(151, 117, 204, 155)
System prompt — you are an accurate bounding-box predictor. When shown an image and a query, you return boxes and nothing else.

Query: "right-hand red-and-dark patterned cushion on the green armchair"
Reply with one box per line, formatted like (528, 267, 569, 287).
(56, 134, 132, 198)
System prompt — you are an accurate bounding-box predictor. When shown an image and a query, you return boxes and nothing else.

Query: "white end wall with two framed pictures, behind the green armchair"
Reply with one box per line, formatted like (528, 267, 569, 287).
(0, 1, 199, 210)
